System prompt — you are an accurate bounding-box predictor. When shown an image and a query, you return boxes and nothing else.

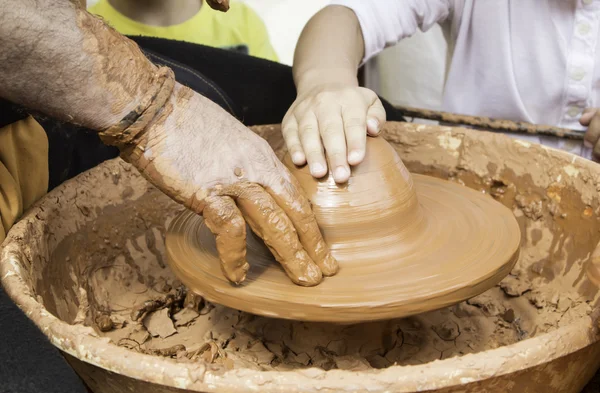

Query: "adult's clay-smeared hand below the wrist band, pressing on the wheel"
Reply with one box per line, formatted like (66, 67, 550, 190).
(123, 85, 338, 286)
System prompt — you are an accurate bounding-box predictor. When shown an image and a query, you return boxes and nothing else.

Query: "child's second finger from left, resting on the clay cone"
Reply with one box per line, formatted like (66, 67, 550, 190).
(298, 112, 327, 178)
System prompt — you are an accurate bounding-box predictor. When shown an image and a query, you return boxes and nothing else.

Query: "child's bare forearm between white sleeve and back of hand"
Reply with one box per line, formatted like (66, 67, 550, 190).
(294, 6, 364, 94)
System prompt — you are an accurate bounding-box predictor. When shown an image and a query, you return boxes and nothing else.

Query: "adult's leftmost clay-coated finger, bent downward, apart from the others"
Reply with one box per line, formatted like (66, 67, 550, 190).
(202, 196, 250, 284)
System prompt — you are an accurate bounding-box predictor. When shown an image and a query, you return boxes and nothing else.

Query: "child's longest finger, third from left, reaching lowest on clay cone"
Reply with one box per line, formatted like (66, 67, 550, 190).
(317, 106, 350, 183)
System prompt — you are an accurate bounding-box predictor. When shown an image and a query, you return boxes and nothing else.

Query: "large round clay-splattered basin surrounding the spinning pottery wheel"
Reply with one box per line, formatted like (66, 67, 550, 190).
(0, 124, 600, 393)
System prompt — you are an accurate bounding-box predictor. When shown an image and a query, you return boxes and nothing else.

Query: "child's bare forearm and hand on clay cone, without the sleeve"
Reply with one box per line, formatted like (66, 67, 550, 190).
(282, 6, 376, 182)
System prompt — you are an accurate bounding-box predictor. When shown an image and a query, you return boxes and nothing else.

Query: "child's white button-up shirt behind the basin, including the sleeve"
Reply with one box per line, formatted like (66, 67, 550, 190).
(332, 0, 600, 156)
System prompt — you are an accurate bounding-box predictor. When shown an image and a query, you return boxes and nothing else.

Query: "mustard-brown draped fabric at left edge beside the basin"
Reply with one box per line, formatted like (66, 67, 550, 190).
(0, 116, 48, 242)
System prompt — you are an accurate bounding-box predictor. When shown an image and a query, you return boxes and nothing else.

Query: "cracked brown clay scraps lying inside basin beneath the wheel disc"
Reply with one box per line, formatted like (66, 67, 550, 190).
(39, 183, 592, 371)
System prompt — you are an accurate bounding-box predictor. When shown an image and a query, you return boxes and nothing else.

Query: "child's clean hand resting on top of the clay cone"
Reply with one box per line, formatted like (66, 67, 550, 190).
(282, 84, 385, 183)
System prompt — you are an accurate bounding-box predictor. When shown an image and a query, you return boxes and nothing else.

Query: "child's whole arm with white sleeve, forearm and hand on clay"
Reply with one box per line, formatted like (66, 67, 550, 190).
(283, 0, 452, 183)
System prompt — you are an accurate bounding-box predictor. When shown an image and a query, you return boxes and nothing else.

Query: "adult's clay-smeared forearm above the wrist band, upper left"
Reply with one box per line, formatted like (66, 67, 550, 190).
(0, 0, 156, 130)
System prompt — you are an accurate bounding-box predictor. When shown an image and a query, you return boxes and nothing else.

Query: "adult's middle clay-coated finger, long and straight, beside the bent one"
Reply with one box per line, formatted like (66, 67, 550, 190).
(224, 183, 323, 286)
